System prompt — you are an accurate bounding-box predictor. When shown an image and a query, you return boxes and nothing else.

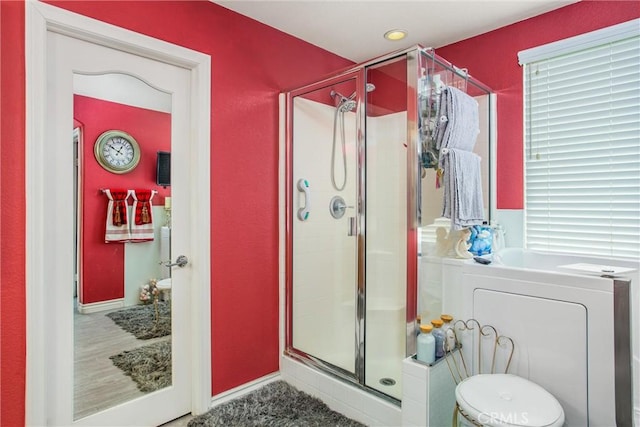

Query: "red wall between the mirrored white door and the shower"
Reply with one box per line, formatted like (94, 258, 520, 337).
(47, 1, 351, 400)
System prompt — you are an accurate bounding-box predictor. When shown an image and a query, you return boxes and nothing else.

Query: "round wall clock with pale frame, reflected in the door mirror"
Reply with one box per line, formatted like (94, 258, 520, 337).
(93, 130, 140, 173)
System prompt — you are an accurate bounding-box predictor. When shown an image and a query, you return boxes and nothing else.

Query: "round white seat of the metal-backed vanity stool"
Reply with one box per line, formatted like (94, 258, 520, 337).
(456, 374, 564, 427)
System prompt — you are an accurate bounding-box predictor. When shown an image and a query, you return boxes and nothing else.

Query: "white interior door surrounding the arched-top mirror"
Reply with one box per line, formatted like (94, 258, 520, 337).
(47, 33, 191, 425)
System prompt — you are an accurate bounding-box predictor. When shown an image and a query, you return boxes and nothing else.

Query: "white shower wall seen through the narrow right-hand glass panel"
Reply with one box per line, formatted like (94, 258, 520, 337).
(365, 112, 407, 399)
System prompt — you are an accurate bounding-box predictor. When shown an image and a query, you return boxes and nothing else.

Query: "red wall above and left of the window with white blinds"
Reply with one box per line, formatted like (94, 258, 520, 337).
(436, 0, 640, 209)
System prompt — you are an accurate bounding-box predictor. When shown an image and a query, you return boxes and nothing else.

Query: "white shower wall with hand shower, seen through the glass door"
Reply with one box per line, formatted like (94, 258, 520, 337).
(292, 97, 357, 372)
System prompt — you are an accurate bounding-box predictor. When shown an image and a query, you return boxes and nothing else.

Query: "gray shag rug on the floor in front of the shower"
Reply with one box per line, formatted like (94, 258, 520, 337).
(187, 381, 364, 427)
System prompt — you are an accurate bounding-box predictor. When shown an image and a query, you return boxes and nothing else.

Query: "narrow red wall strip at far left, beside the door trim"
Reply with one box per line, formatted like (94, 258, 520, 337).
(0, 1, 26, 426)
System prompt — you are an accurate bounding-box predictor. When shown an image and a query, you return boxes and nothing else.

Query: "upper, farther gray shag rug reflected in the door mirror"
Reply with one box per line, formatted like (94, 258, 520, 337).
(107, 301, 171, 340)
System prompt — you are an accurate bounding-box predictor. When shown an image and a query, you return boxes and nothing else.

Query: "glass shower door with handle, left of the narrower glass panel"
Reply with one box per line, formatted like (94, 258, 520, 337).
(287, 75, 359, 376)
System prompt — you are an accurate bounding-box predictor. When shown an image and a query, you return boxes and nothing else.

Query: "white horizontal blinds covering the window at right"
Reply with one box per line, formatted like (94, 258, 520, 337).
(521, 20, 640, 259)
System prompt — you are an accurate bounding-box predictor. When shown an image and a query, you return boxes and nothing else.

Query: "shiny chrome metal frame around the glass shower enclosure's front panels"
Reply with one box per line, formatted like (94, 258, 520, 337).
(284, 45, 425, 403)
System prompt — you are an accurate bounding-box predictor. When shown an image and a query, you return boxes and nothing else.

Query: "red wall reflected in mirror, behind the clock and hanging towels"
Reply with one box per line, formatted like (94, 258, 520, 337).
(73, 95, 171, 304)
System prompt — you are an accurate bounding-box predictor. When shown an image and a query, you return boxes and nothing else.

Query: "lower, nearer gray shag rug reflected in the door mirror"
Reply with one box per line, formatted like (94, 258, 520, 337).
(109, 340, 171, 392)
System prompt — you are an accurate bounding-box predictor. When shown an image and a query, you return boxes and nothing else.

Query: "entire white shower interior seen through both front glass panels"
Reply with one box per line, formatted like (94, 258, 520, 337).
(292, 97, 407, 399)
